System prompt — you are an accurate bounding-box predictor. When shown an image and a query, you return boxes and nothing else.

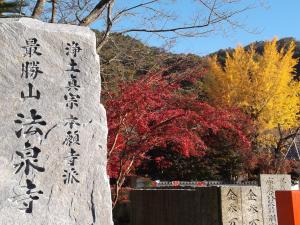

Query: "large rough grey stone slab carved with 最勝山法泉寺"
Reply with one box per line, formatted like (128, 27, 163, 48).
(0, 18, 112, 225)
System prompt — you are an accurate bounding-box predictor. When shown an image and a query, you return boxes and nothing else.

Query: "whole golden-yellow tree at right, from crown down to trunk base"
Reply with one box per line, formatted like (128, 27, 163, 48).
(205, 39, 300, 173)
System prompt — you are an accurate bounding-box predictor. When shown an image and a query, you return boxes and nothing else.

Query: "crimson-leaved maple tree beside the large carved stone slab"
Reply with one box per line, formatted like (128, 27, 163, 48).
(105, 73, 250, 205)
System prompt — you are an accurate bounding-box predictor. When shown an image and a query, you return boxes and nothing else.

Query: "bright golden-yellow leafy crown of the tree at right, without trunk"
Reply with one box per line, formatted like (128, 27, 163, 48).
(205, 39, 300, 142)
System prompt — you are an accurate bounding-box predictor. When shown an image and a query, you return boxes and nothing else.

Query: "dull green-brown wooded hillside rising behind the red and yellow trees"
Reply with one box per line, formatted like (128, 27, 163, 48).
(97, 32, 300, 85)
